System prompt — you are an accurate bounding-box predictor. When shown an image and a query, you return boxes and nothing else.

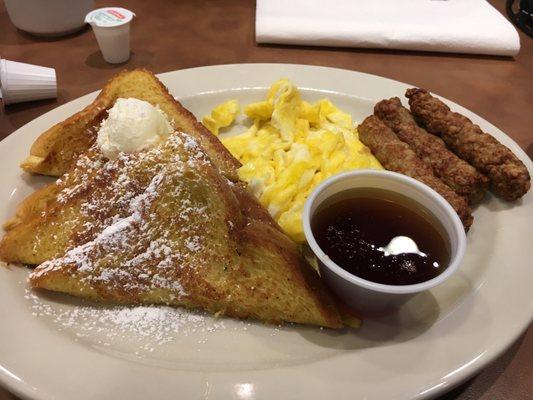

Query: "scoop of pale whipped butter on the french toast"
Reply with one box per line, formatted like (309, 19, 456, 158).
(96, 98, 174, 159)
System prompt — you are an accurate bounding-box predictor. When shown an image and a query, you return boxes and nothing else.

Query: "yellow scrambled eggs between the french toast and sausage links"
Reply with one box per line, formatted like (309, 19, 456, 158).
(203, 79, 383, 243)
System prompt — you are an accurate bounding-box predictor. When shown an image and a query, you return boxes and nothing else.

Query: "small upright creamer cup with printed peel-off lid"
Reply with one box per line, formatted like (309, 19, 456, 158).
(85, 7, 135, 64)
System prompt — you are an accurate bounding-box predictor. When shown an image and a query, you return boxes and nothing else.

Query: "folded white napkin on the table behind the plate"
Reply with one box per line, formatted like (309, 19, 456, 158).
(255, 0, 520, 56)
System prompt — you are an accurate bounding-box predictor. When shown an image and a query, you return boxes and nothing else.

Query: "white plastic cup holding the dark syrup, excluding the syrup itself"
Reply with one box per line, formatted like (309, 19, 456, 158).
(302, 170, 466, 317)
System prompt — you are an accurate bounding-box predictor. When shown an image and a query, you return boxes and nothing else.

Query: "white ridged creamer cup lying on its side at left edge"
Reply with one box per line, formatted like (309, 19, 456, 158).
(0, 59, 57, 105)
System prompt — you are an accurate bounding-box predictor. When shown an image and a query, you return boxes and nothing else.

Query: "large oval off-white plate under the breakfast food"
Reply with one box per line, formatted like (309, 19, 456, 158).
(0, 64, 533, 400)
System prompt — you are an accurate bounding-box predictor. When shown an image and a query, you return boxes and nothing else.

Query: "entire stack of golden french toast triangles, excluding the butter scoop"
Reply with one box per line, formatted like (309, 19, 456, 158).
(0, 70, 342, 328)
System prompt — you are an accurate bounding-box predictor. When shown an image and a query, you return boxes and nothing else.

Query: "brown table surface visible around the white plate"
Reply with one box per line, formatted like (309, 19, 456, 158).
(0, 0, 533, 400)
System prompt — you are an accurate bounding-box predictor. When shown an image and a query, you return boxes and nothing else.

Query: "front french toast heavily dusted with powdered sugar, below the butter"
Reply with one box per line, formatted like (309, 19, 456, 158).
(6, 131, 342, 328)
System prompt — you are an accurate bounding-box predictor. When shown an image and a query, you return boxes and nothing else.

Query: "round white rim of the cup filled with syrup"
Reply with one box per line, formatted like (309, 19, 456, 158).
(302, 170, 466, 294)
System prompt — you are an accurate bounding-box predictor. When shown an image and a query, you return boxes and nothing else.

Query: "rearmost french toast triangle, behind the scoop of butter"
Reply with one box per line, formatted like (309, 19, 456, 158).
(21, 68, 240, 179)
